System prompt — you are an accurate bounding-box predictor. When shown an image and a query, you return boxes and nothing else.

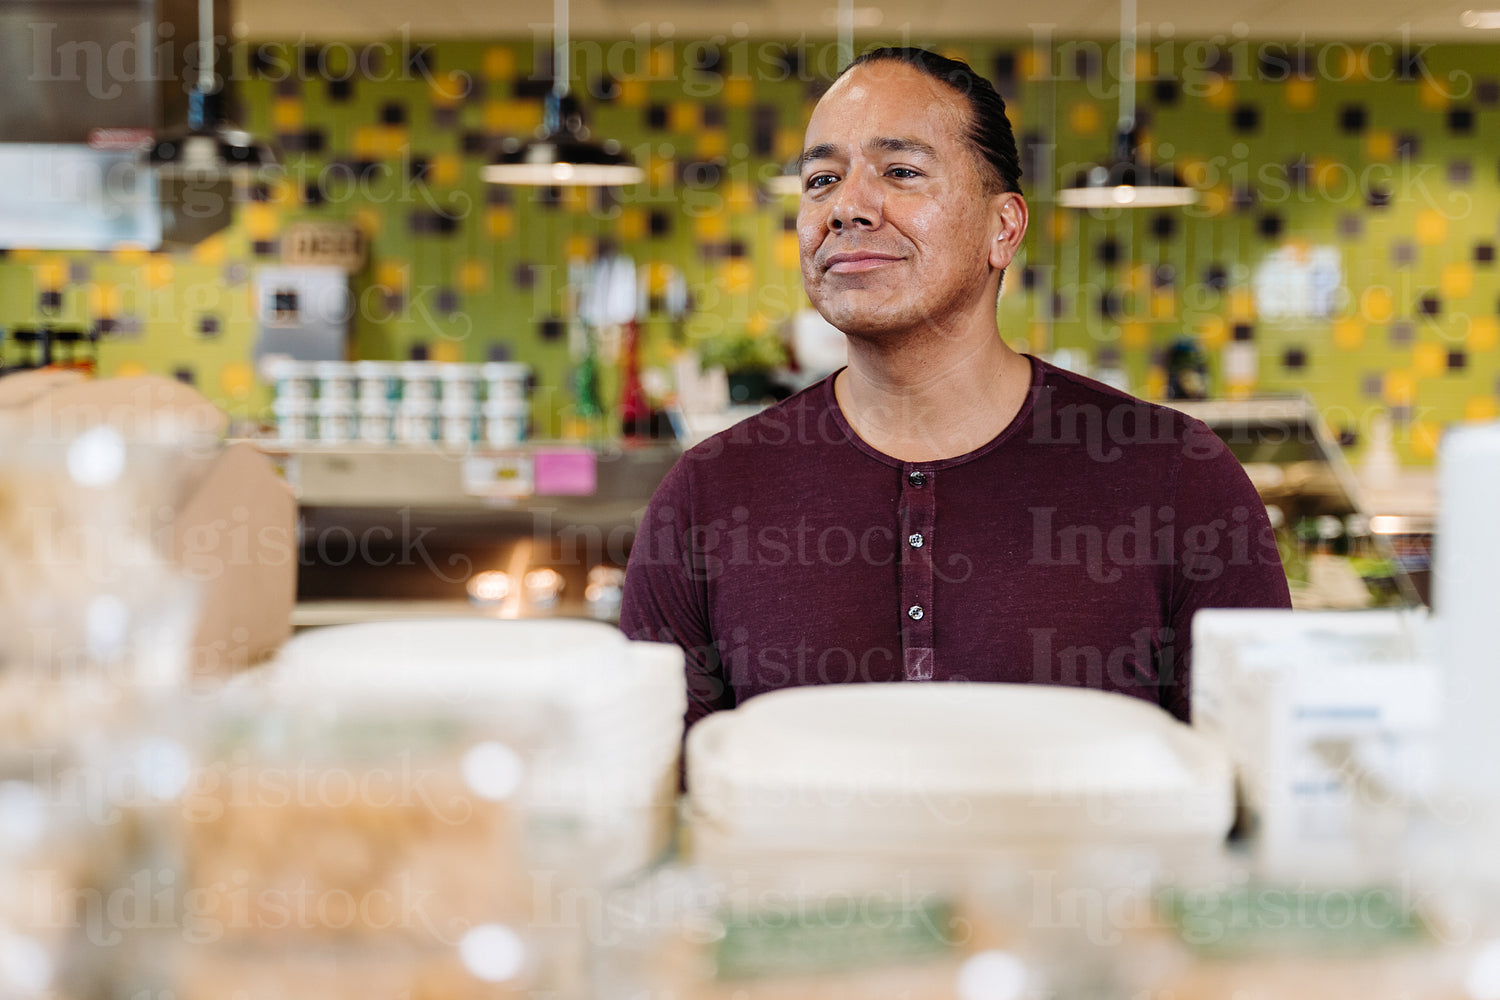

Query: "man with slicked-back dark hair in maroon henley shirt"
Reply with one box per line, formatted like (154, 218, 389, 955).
(621, 49, 1289, 734)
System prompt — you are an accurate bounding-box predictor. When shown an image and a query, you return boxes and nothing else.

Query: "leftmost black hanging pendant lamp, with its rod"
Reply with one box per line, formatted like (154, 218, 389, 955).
(146, 0, 276, 180)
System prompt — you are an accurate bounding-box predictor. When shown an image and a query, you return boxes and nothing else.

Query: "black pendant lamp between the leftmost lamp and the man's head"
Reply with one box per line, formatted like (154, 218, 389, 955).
(480, 0, 647, 187)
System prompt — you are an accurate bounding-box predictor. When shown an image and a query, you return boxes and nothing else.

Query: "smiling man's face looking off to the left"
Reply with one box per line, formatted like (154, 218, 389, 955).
(797, 61, 1025, 344)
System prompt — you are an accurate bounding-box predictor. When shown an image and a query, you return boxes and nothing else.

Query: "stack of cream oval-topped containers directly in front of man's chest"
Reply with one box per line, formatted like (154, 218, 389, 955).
(687, 684, 1233, 861)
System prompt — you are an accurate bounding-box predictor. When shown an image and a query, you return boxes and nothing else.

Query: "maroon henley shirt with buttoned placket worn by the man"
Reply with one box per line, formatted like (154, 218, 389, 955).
(620, 358, 1290, 726)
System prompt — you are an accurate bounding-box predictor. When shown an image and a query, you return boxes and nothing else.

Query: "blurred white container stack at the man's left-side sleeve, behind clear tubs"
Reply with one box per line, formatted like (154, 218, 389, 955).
(270, 619, 686, 880)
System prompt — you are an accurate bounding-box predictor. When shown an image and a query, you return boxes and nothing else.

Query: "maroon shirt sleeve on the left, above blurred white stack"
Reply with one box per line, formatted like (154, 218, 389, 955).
(620, 460, 735, 727)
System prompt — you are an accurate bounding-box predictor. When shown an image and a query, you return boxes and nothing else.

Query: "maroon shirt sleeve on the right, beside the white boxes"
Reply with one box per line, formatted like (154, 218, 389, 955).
(1160, 420, 1292, 723)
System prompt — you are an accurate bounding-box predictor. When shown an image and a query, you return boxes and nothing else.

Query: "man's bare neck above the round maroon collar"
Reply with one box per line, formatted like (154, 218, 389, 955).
(834, 331, 1032, 462)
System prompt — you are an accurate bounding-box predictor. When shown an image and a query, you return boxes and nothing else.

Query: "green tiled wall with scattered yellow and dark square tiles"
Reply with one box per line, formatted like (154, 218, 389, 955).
(0, 34, 1500, 463)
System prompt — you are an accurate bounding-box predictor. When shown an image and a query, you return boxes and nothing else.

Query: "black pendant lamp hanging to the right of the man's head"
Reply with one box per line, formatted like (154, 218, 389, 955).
(1058, 0, 1199, 208)
